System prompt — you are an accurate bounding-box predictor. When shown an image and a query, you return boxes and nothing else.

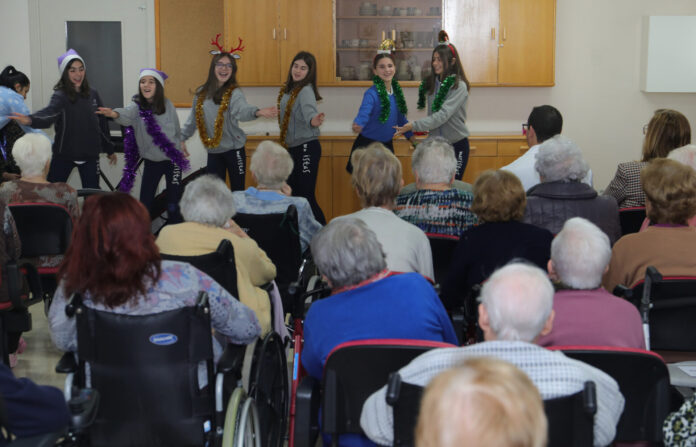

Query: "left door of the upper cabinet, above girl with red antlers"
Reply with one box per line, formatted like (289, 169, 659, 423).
(224, 0, 281, 87)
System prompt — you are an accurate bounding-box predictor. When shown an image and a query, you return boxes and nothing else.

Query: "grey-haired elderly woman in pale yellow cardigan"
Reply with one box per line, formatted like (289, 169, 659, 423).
(157, 175, 276, 334)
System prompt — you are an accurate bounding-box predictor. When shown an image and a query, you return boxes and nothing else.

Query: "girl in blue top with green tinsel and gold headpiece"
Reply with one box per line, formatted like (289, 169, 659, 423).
(346, 39, 415, 173)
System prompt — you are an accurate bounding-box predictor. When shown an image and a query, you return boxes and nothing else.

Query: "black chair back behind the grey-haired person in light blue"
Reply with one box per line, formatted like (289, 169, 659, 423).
(234, 205, 302, 309)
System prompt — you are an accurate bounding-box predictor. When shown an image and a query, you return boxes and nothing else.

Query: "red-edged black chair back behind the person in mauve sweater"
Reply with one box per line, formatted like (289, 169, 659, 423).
(553, 346, 670, 442)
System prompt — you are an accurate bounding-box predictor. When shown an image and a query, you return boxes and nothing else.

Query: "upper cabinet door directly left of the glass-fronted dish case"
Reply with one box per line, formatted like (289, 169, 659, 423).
(279, 0, 336, 84)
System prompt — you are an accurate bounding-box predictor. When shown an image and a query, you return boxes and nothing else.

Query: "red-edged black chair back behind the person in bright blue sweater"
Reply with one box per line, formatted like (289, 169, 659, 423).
(322, 340, 454, 442)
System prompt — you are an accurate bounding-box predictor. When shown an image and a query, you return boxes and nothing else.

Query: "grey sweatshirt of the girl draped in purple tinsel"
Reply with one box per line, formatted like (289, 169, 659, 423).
(114, 98, 181, 161)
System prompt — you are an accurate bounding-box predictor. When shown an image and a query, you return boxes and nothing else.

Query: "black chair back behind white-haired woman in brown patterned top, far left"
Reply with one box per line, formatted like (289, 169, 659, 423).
(9, 203, 73, 258)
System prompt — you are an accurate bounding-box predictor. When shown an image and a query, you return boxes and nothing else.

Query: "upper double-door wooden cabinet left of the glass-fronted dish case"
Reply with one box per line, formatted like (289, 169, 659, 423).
(224, 0, 334, 86)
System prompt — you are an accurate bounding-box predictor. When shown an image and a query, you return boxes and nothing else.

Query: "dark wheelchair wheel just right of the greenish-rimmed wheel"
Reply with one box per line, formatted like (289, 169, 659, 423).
(249, 332, 289, 447)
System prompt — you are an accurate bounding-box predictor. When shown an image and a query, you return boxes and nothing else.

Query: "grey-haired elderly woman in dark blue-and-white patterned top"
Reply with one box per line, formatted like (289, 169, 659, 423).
(394, 137, 476, 237)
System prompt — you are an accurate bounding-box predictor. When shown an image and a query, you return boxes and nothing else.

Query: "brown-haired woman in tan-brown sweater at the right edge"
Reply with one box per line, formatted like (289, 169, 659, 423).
(602, 158, 696, 291)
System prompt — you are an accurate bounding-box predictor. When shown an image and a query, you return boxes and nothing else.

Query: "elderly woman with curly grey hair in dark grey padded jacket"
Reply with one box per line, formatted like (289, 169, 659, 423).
(524, 135, 621, 244)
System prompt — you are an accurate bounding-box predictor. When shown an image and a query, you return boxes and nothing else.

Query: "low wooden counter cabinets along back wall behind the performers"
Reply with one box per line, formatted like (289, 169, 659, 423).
(246, 135, 529, 221)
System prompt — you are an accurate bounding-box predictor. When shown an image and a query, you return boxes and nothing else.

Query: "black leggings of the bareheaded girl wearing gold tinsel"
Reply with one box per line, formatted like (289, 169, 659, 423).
(288, 140, 326, 225)
